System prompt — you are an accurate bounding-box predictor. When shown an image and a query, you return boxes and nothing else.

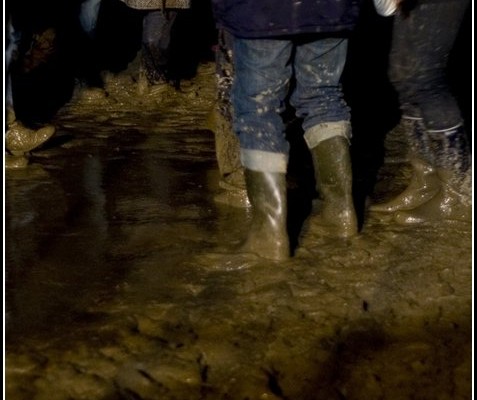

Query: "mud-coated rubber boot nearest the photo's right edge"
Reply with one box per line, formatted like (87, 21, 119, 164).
(394, 126, 472, 224)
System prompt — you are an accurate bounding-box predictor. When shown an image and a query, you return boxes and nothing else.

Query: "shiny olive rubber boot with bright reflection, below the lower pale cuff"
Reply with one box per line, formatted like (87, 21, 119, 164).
(241, 169, 290, 261)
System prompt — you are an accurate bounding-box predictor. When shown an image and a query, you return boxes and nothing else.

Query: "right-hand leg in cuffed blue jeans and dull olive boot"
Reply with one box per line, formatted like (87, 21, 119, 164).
(291, 38, 358, 237)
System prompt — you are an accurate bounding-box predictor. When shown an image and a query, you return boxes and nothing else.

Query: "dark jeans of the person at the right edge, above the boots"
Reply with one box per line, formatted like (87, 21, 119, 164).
(389, 0, 470, 131)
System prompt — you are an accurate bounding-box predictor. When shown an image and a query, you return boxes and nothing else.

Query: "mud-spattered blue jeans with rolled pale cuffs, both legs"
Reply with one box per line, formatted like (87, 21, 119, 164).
(232, 37, 350, 172)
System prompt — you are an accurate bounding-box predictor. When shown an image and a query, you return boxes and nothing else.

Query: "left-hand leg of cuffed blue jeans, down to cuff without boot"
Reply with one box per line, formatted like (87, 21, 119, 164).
(232, 38, 293, 173)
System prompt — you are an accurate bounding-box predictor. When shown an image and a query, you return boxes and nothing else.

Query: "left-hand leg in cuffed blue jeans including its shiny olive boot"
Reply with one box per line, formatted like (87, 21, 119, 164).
(232, 38, 292, 260)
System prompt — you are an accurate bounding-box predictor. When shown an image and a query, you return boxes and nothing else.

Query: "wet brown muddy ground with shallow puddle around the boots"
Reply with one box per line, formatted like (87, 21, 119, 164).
(5, 63, 472, 400)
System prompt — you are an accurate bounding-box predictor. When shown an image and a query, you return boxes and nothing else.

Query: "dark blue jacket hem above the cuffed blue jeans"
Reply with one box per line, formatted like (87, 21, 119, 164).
(212, 0, 361, 38)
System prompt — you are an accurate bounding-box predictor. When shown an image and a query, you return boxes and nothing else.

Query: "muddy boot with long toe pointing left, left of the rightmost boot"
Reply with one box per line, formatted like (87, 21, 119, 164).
(369, 116, 440, 213)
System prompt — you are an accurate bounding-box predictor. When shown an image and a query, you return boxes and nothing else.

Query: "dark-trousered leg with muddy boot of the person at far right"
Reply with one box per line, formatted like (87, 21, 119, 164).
(378, 0, 471, 223)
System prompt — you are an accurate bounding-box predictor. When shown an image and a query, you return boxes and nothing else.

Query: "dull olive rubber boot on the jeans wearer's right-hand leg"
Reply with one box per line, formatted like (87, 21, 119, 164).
(308, 136, 358, 238)
